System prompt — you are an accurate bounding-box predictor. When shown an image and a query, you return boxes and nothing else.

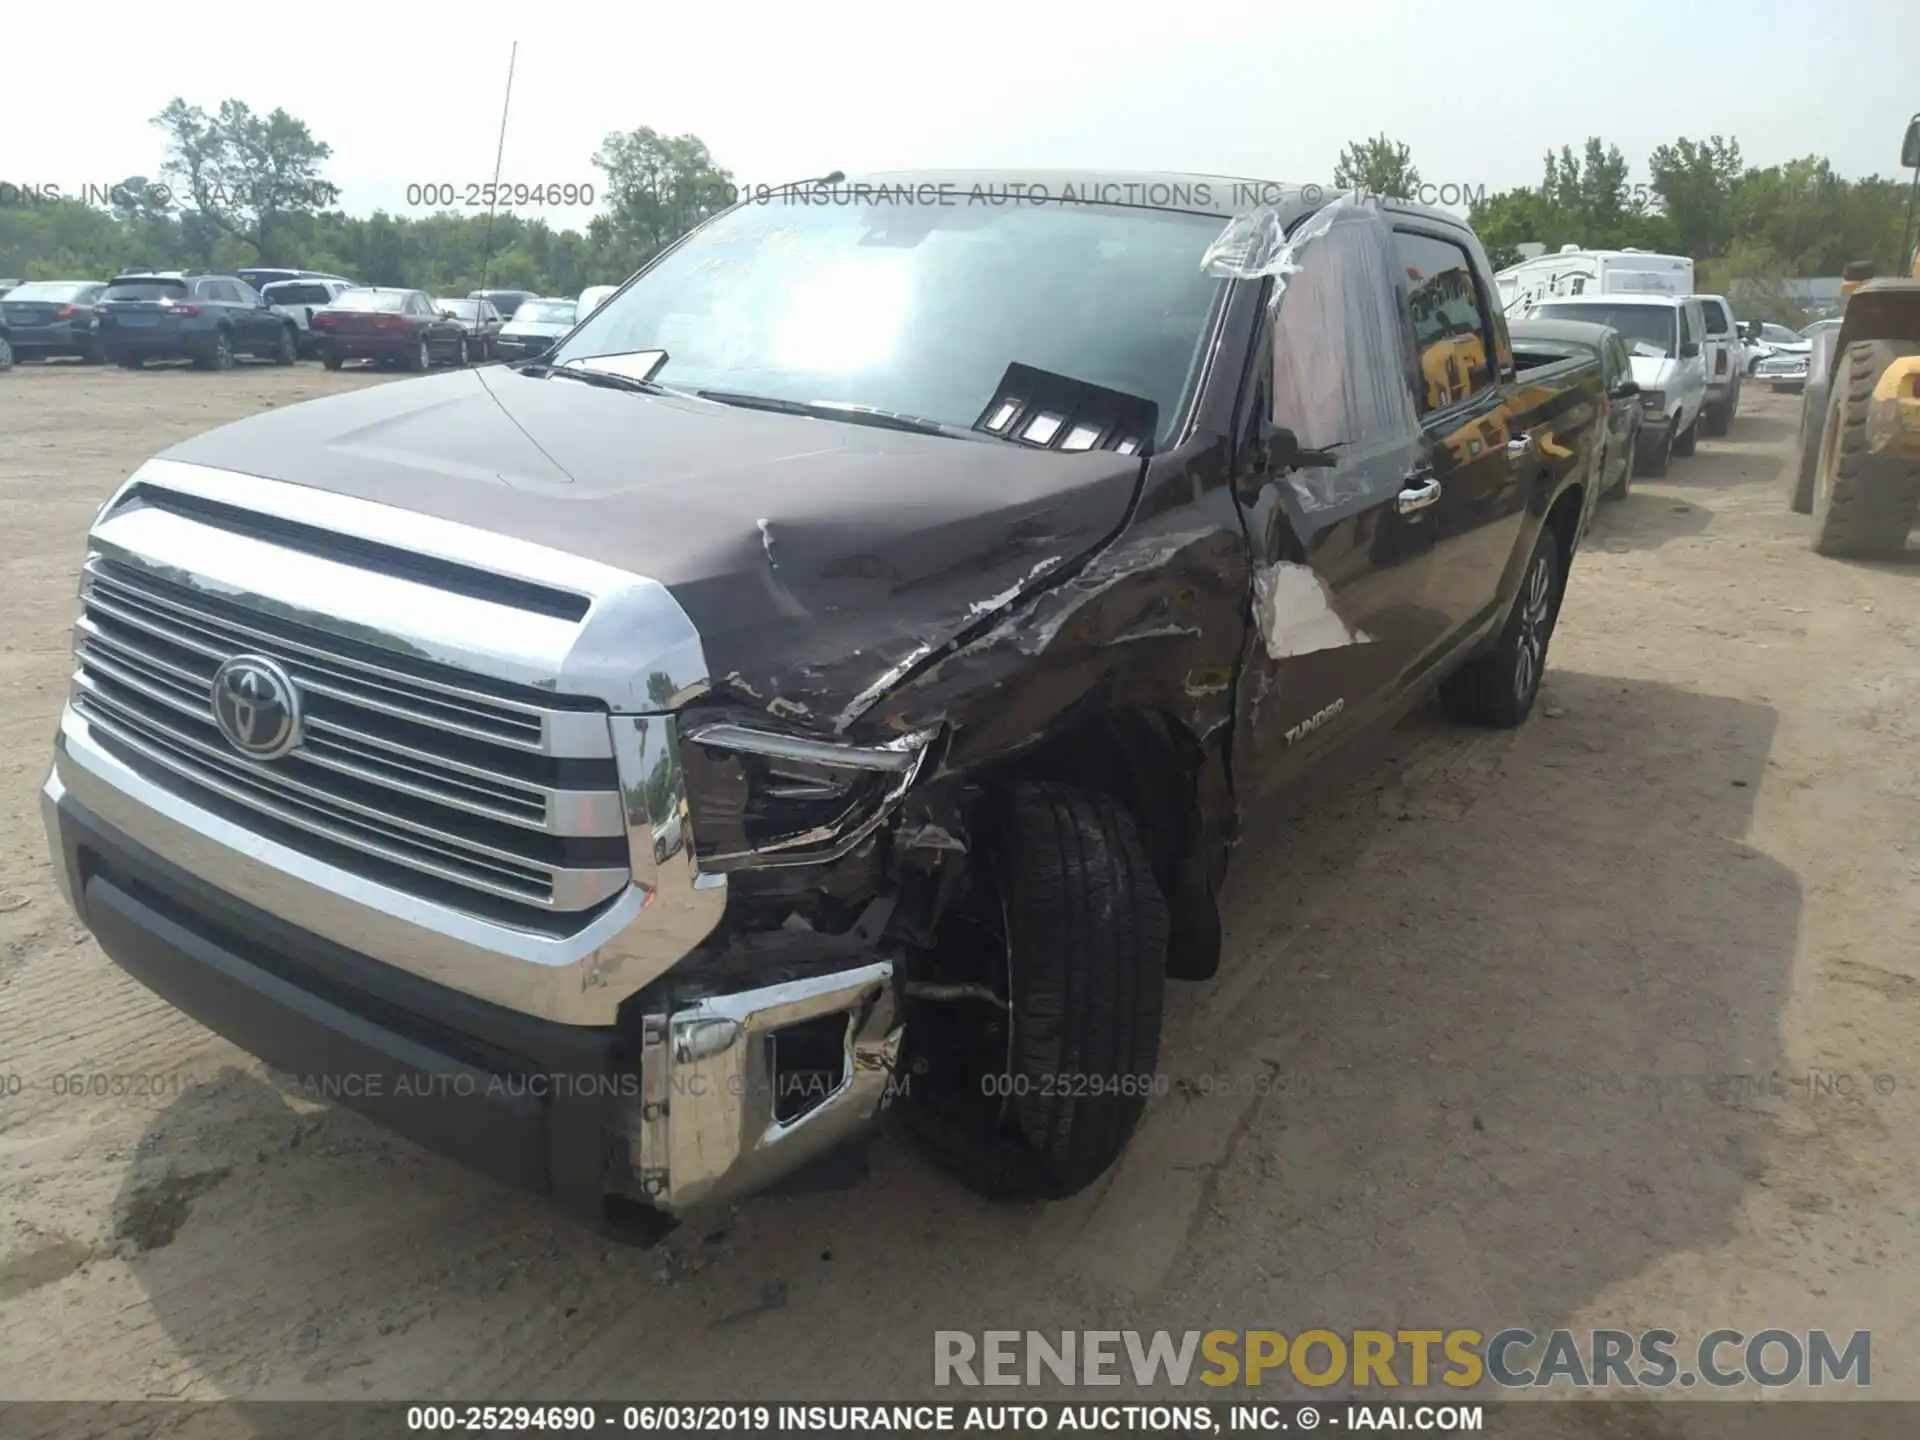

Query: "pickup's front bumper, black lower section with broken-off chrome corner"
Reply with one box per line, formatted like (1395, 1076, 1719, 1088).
(40, 730, 902, 1223)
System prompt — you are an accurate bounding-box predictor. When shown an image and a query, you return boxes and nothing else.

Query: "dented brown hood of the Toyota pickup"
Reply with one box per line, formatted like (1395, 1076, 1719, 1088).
(165, 367, 1144, 728)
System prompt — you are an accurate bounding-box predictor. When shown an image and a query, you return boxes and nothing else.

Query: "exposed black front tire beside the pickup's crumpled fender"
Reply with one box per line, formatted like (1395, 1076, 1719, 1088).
(906, 783, 1171, 1200)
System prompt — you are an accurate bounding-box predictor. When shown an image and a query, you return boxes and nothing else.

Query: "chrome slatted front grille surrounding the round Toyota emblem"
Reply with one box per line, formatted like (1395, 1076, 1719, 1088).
(73, 555, 632, 925)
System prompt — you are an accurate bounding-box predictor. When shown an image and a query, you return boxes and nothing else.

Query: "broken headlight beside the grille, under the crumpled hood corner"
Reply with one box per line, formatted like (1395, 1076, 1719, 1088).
(680, 720, 935, 870)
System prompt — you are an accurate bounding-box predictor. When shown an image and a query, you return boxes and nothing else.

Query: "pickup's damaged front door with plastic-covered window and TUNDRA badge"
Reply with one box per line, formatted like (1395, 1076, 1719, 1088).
(1233, 209, 1440, 793)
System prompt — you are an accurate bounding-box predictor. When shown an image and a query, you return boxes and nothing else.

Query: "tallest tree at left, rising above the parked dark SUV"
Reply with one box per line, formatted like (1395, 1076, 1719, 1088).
(154, 98, 332, 263)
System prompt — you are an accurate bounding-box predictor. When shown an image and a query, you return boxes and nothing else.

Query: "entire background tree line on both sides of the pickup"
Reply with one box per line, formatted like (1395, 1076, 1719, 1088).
(0, 100, 1907, 323)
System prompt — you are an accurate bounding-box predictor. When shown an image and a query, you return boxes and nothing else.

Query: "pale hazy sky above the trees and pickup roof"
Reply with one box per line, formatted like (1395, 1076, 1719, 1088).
(0, 0, 1920, 225)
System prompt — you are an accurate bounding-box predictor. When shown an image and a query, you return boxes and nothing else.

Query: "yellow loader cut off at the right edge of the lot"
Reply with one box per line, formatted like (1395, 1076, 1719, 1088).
(1793, 115, 1920, 559)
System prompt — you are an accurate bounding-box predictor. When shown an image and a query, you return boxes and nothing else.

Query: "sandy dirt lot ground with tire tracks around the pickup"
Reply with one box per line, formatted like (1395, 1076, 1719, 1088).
(0, 365, 1920, 1434)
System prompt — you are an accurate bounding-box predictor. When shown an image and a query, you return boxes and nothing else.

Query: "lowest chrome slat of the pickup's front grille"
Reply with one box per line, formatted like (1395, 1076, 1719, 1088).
(77, 685, 626, 910)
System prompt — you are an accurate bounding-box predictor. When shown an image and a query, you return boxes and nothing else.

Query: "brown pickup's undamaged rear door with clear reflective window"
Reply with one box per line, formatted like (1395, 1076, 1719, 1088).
(1394, 219, 1534, 659)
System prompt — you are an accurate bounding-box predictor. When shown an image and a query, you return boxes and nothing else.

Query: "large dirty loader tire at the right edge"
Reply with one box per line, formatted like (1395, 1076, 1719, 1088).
(1812, 340, 1920, 559)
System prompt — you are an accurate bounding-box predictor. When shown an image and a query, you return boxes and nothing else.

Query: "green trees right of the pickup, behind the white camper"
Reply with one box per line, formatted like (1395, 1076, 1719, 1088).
(1334, 134, 1907, 324)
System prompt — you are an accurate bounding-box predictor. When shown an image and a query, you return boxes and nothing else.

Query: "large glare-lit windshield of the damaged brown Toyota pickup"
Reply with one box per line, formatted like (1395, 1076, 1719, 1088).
(555, 202, 1225, 445)
